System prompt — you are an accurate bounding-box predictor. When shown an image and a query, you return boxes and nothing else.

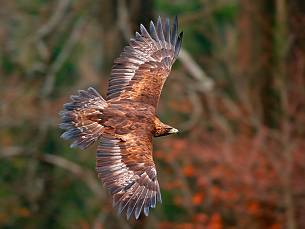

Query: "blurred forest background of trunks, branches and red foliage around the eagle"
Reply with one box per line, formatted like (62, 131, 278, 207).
(0, 0, 305, 229)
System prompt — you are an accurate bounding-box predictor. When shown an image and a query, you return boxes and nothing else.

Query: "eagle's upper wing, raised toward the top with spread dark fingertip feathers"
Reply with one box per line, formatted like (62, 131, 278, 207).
(107, 17, 183, 107)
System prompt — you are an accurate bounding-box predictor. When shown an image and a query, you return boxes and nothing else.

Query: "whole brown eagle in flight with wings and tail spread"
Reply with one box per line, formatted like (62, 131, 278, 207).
(60, 17, 183, 219)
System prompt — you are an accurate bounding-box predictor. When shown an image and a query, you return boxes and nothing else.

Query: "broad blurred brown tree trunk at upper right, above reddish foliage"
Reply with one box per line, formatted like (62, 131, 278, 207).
(238, 0, 282, 128)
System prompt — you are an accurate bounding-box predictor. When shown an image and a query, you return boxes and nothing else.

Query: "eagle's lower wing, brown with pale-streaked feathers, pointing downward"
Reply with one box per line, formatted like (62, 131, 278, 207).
(96, 129, 161, 219)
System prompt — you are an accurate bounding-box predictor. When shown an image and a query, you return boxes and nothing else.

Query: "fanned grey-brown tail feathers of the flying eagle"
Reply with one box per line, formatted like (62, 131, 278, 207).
(59, 87, 107, 149)
